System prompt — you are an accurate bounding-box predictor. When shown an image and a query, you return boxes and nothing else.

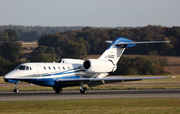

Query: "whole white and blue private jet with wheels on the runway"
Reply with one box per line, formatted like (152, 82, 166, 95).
(4, 37, 172, 93)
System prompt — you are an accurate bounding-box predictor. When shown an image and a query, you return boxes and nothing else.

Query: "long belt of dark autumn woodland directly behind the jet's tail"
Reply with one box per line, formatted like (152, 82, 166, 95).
(35, 25, 180, 58)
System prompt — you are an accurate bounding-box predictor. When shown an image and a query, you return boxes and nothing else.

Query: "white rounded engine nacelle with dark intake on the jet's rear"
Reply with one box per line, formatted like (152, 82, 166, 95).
(83, 59, 116, 73)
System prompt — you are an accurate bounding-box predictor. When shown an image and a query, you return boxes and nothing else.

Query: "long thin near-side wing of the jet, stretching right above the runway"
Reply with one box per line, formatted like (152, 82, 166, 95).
(56, 76, 175, 87)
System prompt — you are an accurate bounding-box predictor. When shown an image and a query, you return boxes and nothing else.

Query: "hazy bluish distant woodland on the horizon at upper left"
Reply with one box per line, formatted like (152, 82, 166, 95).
(0, 25, 117, 42)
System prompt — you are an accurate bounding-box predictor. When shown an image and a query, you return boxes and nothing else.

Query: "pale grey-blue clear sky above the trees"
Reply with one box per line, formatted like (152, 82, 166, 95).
(0, 0, 180, 27)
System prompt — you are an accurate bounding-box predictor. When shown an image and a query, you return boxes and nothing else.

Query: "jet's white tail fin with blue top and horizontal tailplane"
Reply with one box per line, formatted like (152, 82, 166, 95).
(98, 37, 170, 65)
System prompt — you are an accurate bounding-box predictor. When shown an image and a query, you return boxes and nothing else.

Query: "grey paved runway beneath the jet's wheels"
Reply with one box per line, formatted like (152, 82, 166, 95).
(0, 89, 180, 101)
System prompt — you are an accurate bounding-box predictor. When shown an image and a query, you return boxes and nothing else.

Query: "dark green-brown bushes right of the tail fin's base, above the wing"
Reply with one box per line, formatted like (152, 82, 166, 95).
(114, 56, 168, 75)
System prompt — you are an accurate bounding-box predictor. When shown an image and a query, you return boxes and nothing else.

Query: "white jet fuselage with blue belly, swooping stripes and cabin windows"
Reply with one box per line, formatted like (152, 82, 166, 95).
(4, 63, 105, 86)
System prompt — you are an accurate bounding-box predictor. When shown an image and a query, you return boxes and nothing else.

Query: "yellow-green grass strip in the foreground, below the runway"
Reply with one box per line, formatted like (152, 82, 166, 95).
(0, 98, 180, 114)
